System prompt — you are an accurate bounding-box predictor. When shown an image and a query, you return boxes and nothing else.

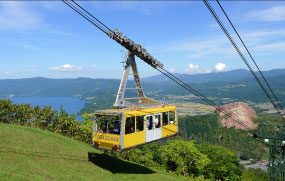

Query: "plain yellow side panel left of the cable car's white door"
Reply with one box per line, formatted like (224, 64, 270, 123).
(124, 131, 145, 148)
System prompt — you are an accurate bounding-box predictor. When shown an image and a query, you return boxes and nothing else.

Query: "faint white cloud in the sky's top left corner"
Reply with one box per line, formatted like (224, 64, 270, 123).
(0, 1, 42, 30)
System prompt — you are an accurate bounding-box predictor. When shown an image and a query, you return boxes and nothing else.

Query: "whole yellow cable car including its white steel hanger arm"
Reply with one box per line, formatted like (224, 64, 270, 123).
(92, 52, 178, 151)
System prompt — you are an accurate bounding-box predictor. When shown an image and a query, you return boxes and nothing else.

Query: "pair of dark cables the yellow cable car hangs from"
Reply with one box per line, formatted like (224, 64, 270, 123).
(62, 0, 250, 130)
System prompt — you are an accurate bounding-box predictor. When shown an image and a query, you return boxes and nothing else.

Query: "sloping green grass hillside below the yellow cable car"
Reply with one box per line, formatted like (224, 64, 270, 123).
(0, 123, 186, 181)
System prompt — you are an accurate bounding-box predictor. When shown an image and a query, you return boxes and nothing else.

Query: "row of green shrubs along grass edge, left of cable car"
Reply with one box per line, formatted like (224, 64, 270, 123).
(0, 100, 92, 143)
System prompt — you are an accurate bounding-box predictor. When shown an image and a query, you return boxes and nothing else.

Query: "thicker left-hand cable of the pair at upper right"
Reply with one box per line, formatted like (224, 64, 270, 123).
(203, 0, 285, 121)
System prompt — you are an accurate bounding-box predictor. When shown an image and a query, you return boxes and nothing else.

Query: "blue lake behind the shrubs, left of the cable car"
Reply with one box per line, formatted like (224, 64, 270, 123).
(11, 97, 85, 121)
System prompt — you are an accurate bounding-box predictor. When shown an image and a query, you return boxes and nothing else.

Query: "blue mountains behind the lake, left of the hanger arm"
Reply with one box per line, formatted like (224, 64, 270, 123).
(0, 77, 119, 97)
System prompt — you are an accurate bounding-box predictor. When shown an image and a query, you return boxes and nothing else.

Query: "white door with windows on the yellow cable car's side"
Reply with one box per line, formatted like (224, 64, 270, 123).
(146, 114, 162, 142)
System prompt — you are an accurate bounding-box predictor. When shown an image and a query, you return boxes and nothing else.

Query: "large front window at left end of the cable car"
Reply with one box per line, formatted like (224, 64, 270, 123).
(96, 115, 121, 134)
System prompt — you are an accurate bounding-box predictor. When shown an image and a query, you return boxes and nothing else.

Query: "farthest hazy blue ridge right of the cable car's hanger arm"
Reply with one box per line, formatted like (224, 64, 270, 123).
(143, 69, 285, 83)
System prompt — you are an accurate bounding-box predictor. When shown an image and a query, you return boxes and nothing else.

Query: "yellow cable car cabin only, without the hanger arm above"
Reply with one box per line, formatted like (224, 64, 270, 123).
(93, 106, 178, 150)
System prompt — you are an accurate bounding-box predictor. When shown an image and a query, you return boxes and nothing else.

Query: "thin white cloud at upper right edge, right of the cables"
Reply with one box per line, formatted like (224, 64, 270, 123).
(249, 6, 285, 22)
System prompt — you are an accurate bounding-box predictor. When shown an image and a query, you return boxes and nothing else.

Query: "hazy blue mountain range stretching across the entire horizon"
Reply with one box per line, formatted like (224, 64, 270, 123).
(0, 69, 285, 98)
